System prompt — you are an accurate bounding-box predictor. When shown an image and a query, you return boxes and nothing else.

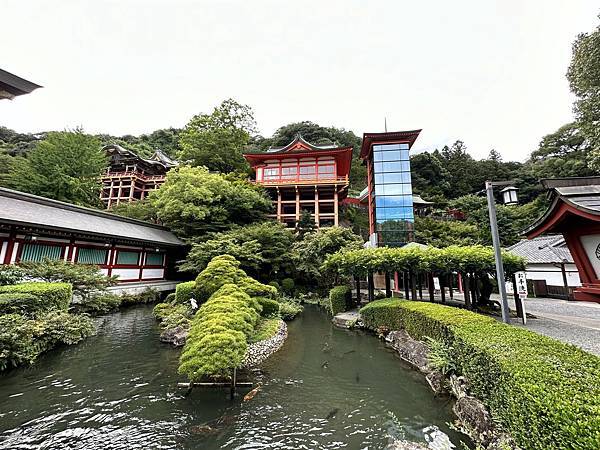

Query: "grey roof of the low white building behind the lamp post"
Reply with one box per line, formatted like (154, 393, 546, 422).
(508, 235, 573, 264)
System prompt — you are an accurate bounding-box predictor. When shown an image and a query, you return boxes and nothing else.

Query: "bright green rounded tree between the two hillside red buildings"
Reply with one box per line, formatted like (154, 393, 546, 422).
(149, 166, 272, 239)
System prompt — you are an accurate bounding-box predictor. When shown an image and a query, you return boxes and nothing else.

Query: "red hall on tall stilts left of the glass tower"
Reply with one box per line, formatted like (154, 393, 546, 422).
(244, 134, 352, 227)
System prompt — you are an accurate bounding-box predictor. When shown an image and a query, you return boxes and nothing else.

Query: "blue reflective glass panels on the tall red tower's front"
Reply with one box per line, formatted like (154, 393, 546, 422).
(372, 144, 414, 247)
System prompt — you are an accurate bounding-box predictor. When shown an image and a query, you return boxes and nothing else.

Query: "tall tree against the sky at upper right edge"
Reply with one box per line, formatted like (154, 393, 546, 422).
(567, 16, 600, 152)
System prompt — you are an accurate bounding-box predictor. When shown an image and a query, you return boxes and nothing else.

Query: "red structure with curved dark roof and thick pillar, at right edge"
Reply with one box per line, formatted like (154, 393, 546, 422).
(525, 177, 600, 302)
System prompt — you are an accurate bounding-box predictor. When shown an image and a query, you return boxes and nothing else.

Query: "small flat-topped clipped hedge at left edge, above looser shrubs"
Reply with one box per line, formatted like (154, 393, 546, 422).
(0, 282, 73, 316)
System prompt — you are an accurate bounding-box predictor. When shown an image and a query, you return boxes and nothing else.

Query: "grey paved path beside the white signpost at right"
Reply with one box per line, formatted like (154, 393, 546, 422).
(508, 298, 600, 356)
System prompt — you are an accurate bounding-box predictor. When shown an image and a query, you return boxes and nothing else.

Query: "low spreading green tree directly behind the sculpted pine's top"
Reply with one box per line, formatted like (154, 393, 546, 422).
(181, 222, 294, 281)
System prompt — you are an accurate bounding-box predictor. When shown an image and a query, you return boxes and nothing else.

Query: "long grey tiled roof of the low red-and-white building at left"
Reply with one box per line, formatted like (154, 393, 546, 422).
(0, 188, 183, 246)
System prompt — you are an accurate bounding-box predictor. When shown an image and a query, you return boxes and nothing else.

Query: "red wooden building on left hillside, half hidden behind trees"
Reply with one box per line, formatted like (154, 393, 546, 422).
(100, 144, 177, 208)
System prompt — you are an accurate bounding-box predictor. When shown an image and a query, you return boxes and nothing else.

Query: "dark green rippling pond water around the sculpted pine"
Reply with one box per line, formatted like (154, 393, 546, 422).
(0, 306, 467, 449)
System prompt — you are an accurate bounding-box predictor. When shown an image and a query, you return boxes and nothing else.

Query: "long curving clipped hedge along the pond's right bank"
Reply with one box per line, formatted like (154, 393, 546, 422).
(361, 299, 600, 450)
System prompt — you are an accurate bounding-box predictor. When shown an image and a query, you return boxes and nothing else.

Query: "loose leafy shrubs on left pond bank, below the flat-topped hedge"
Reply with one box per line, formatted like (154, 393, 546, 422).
(0, 311, 94, 371)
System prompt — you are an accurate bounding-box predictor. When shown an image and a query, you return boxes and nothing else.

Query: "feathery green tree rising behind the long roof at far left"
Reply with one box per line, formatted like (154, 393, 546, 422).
(6, 129, 107, 206)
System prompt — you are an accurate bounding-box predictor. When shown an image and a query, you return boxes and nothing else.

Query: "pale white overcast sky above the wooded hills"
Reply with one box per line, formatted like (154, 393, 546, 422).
(0, 0, 600, 161)
